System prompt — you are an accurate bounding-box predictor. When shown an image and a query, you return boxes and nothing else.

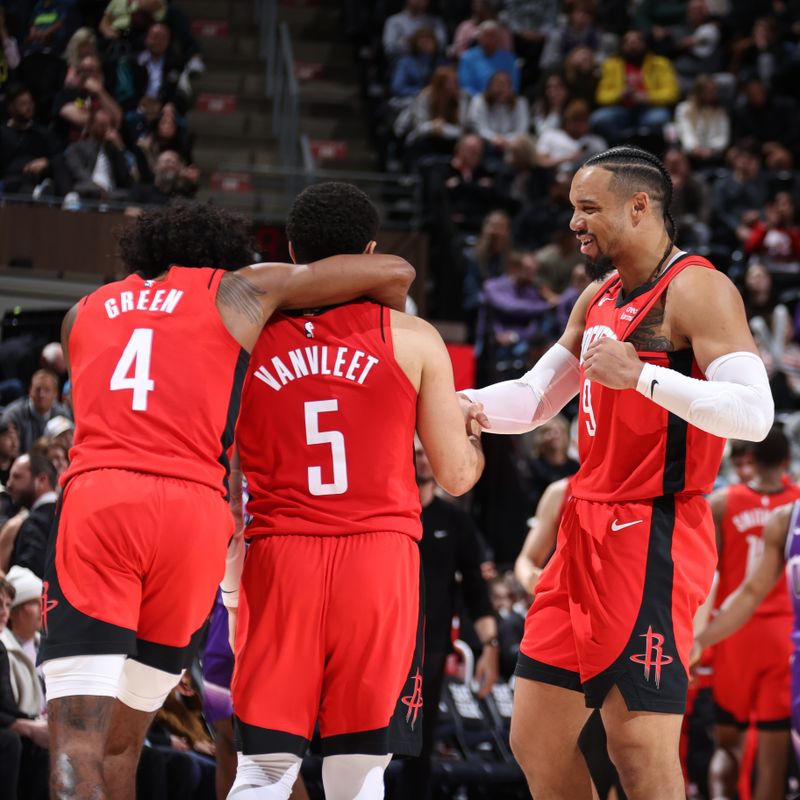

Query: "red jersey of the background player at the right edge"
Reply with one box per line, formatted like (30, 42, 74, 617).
(716, 481, 800, 617)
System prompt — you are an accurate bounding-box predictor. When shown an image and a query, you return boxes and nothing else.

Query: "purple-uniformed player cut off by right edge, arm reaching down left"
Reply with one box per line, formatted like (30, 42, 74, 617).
(691, 501, 800, 780)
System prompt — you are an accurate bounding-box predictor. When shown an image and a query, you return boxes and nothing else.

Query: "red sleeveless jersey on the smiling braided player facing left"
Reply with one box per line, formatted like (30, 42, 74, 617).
(573, 254, 725, 502)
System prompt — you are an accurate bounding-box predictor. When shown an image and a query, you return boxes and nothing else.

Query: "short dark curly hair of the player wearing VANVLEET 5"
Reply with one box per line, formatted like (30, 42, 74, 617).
(286, 181, 380, 263)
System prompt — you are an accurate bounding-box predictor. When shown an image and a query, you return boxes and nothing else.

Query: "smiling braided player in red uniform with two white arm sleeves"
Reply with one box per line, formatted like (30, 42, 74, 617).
(466, 147, 774, 800)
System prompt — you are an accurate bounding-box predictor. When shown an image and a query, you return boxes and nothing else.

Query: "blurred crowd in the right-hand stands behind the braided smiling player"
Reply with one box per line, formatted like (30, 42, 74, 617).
(348, 0, 800, 411)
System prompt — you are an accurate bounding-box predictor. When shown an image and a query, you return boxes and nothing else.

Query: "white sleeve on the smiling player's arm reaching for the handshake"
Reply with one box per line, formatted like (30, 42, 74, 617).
(462, 344, 580, 434)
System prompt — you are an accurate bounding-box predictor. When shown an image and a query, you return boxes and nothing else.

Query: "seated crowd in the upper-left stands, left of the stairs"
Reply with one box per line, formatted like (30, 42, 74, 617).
(0, 0, 205, 209)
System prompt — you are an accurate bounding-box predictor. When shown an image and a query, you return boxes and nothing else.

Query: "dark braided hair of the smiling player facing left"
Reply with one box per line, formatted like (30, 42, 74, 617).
(582, 145, 677, 241)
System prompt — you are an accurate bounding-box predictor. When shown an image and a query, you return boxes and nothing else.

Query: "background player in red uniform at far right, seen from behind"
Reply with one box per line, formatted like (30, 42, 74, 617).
(696, 427, 800, 800)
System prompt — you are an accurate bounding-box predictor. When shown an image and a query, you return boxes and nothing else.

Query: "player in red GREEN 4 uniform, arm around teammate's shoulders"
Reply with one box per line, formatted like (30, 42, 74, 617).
(41, 205, 413, 800)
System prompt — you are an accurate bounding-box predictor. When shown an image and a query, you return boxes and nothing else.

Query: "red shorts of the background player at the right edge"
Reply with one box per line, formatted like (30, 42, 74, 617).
(712, 615, 794, 730)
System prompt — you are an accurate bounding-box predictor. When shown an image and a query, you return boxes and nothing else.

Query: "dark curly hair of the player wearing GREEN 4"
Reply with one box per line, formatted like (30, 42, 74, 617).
(117, 202, 256, 278)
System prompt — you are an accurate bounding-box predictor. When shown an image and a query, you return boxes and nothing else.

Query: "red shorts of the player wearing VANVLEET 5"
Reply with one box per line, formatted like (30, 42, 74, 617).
(231, 532, 423, 755)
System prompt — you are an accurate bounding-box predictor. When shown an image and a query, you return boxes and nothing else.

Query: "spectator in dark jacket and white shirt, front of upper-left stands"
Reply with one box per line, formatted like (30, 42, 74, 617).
(64, 108, 133, 200)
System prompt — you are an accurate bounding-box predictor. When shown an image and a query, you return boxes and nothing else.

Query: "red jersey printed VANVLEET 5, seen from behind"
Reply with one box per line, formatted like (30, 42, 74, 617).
(236, 302, 422, 539)
